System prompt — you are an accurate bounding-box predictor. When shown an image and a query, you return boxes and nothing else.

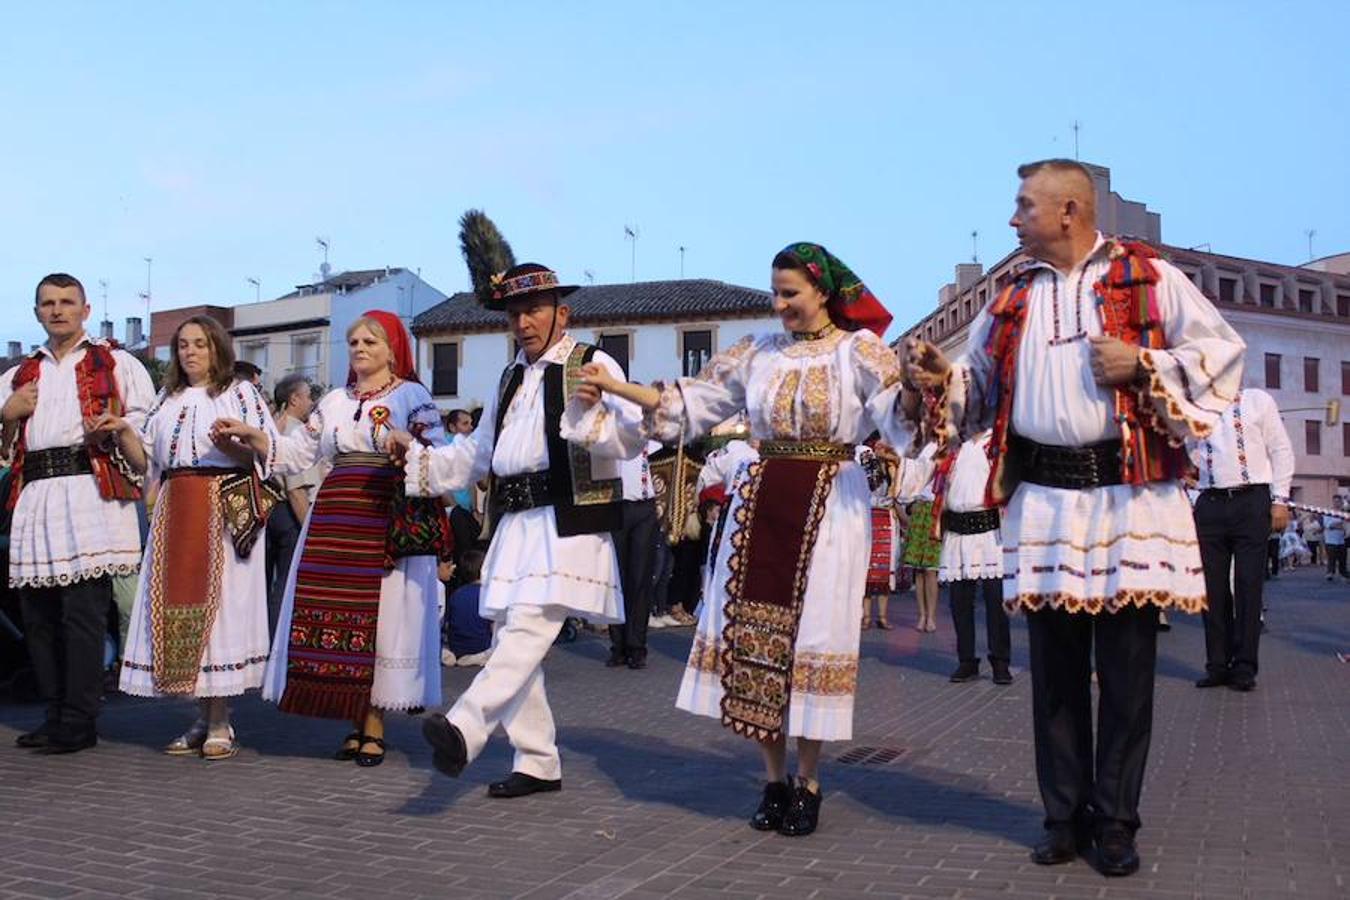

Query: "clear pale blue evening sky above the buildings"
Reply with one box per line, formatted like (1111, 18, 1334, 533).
(0, 0, 1350, 343)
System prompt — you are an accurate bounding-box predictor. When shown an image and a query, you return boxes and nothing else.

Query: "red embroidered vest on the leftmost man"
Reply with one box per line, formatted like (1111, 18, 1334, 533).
(9, 341, 140, 509)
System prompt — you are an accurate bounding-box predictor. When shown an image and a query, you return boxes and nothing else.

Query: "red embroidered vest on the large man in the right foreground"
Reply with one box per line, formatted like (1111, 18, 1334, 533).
(984, 240, 1189, 506)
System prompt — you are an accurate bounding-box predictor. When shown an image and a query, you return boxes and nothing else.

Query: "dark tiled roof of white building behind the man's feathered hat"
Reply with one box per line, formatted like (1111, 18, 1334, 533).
(413, 278, 772, 335)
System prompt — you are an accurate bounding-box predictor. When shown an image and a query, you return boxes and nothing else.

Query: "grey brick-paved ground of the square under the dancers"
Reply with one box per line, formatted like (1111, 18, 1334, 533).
(0, 569, 1350, 900)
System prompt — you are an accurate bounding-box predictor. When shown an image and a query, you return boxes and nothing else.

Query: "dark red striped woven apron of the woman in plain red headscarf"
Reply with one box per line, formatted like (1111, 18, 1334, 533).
(278, 453, 402, 722)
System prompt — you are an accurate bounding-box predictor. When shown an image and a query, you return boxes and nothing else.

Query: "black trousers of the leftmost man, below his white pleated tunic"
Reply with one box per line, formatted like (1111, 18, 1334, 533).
(19, 575, 112, 734)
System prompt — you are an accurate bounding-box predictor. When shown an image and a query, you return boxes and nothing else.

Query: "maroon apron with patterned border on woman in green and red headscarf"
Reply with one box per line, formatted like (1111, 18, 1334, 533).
(721, 459, 840, 741)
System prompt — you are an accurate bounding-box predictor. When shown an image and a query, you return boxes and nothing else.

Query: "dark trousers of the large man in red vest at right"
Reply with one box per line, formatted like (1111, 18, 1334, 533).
(1026, 606, 1158, 833)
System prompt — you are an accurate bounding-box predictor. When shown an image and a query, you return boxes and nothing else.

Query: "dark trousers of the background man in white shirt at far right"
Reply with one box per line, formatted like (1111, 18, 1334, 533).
(1195, 484, 1270, 676)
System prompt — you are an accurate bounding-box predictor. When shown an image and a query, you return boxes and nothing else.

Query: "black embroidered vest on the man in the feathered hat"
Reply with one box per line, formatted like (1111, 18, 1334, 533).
(493, 341, 624, 537)
